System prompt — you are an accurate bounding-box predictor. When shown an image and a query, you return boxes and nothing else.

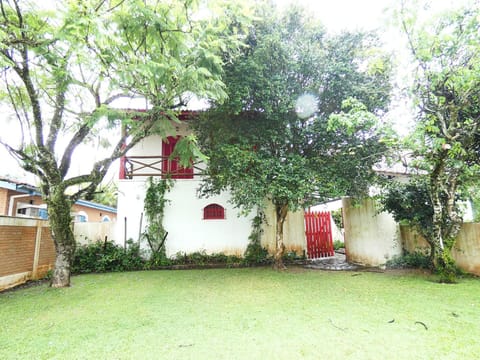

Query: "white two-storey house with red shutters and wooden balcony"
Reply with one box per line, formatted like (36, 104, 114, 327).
(116, 112, 305, 256)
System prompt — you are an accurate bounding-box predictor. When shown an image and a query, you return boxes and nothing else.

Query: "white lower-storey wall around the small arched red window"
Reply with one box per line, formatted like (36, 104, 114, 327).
(116, 179, 252, 256)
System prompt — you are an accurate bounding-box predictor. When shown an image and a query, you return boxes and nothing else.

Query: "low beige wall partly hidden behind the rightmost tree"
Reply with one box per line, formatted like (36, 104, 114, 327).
(401, 223, 480, 276)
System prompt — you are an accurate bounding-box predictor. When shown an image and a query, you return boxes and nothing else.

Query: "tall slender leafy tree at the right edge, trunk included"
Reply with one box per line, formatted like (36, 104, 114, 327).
(382, 2, 480, 282)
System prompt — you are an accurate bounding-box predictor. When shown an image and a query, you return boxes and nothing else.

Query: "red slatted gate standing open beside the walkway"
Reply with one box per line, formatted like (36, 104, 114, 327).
(305, 211, 335, 259)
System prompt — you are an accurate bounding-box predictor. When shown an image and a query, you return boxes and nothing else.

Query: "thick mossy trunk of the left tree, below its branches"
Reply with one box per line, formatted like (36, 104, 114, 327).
(47, 189, 75, 288)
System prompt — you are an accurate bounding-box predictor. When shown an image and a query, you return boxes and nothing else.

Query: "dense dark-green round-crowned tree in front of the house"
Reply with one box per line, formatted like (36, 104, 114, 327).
(194, 6, 390, 269)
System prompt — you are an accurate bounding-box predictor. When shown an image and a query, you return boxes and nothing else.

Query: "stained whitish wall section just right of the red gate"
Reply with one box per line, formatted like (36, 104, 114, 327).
(342, 198, 402, 266)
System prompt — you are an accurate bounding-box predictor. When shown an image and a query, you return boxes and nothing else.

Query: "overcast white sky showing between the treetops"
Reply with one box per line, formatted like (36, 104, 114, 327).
(0, 0, 476, 182)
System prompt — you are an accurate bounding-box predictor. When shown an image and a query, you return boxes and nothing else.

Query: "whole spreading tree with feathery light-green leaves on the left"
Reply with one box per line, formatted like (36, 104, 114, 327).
(0, 0, 248, 287)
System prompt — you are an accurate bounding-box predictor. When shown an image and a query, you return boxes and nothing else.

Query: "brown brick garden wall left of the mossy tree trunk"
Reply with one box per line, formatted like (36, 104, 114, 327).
(0, 216, 55, 291)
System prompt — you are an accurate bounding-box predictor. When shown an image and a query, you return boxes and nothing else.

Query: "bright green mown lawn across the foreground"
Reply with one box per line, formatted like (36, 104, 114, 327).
(0, 268, 480, 359)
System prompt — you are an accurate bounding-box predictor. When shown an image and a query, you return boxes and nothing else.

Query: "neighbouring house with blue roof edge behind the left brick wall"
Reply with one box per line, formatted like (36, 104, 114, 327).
(0, 178, 117, 222)
